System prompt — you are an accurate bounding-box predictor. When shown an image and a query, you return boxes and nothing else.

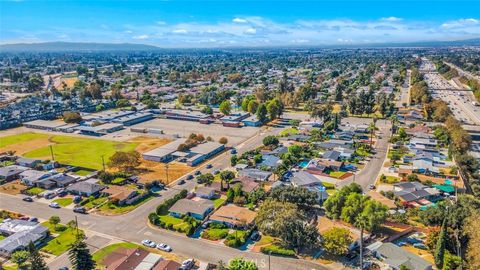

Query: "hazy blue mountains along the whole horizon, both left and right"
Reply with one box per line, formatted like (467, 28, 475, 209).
(0, 38, 480, 52)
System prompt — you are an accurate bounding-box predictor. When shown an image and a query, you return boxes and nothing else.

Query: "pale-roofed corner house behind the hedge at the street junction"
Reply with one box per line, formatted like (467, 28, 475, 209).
(169, 198, 214, 220)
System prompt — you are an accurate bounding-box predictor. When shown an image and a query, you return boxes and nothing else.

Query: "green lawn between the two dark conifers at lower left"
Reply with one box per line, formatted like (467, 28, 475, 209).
(41, 221, 83, 256)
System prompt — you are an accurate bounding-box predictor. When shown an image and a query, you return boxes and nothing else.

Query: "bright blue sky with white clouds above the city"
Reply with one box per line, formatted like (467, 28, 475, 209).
(0, 0, 480, 47)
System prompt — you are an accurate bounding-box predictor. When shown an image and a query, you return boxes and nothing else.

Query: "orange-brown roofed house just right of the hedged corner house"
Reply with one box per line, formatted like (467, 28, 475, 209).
(209, 204, 257, 228)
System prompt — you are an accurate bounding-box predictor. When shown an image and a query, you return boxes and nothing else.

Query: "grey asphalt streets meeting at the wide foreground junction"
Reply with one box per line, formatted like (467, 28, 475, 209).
(0, 124, 343, 270)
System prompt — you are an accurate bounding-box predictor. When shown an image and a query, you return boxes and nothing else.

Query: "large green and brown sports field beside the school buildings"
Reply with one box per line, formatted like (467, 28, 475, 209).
(0, 132, 138, 170)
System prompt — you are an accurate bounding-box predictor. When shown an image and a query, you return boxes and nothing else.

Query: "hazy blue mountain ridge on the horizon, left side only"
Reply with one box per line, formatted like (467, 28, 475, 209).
(0, 41, 160, 52)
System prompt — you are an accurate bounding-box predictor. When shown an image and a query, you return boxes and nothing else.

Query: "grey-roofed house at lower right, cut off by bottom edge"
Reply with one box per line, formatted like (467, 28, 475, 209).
(367, 241, 433, 270)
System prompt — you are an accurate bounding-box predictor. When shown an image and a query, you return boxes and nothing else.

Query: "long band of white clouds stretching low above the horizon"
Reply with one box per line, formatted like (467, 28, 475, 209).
(14, 15, 480, 47)
